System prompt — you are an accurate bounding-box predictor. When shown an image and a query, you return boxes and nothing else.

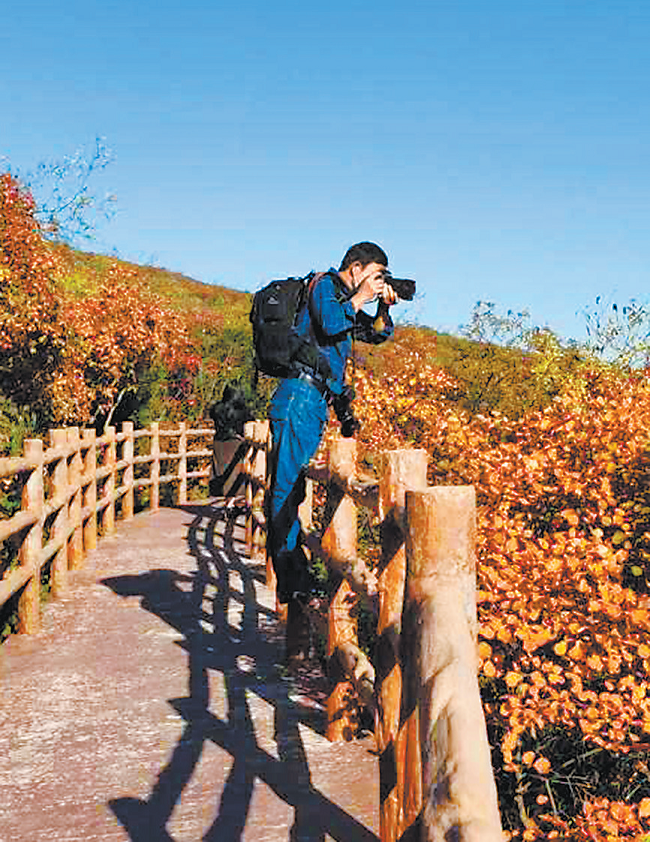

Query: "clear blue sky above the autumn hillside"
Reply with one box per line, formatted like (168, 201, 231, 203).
(0, 0, 650, 338)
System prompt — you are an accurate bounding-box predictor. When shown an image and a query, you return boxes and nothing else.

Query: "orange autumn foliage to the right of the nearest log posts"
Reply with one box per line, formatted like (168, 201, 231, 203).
(346, 330, 650, 842)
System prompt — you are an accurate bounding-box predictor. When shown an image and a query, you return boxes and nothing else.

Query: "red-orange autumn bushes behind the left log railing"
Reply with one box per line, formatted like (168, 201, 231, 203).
(0, 173, 220, 426)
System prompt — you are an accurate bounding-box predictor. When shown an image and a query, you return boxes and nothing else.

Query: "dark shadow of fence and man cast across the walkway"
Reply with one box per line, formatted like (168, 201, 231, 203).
(103, 505, 377, 842)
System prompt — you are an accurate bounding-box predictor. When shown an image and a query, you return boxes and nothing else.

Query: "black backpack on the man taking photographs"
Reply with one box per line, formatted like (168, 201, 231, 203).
(250, 272, 329, 377)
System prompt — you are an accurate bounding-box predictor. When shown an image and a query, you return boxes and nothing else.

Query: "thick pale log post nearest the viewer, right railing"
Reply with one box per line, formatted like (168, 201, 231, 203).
(402, 486, 503, 842)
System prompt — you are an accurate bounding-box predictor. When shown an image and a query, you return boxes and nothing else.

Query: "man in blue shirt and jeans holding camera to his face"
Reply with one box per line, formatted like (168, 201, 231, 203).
(267, 242, 397, 615)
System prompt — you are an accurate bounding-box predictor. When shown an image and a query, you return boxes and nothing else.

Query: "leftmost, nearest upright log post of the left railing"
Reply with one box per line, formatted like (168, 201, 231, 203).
(18, 439, 44, 634)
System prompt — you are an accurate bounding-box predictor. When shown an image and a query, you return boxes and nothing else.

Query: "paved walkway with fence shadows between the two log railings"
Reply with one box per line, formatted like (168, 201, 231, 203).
(0, 504, 379, 842)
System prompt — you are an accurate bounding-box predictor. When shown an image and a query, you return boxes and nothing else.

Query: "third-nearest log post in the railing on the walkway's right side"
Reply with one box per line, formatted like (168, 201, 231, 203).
(321, 438, 359, 742)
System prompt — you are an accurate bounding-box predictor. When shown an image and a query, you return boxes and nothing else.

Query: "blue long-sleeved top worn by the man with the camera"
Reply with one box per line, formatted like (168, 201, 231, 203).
(295, 269, 393, 394)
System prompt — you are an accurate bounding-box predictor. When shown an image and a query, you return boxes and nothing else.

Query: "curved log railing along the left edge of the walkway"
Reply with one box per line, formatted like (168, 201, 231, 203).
(0, 422, 214, 633)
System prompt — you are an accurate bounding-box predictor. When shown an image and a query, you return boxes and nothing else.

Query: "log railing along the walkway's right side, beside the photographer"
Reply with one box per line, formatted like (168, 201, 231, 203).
(240, 422, 503, 842)
